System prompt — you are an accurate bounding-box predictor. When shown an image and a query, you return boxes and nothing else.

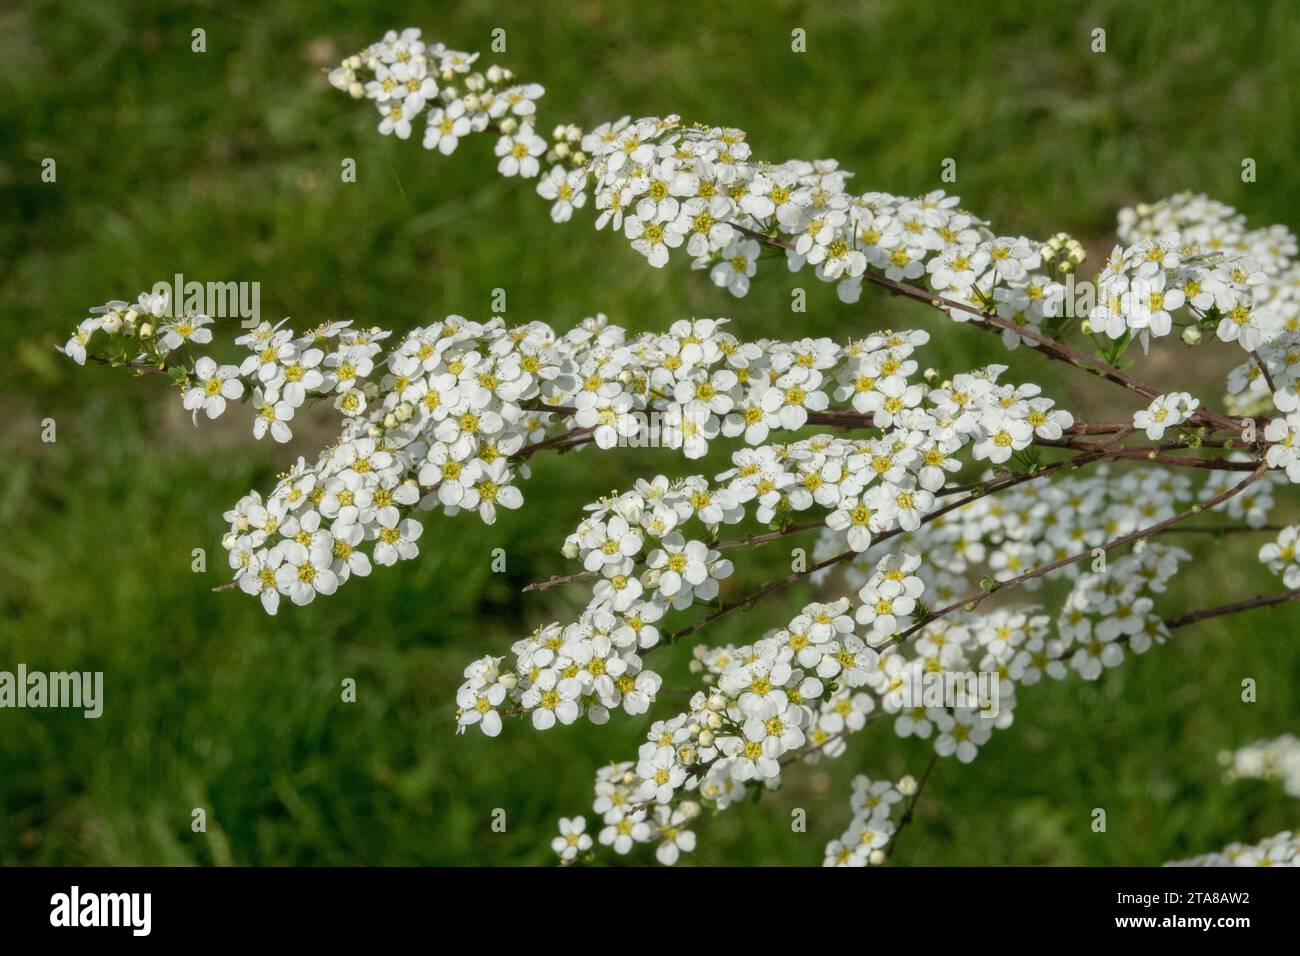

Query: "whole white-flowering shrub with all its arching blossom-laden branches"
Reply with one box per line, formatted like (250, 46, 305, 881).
(64, 30, 1300, 865)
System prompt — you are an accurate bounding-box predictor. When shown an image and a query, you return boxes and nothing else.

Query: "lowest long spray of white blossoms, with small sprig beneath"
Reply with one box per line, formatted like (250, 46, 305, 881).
(548, 528, 1188, 865)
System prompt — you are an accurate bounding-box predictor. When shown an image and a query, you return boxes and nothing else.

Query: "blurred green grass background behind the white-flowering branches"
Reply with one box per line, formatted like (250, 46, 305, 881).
(0, 0, 1300, 864)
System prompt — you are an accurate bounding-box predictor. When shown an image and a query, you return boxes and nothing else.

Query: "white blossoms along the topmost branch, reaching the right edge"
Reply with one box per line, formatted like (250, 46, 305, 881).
(332, 30, 1300, 382)
